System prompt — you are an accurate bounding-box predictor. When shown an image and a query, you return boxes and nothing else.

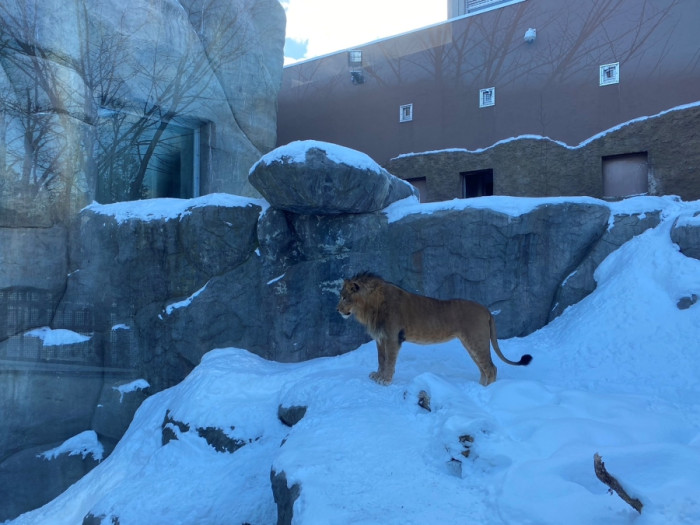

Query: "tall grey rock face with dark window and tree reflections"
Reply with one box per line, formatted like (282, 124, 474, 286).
(0, 0, 285, 226)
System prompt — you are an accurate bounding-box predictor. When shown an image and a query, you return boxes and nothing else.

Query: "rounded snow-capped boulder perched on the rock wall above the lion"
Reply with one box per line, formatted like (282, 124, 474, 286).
(250, 140, 416, 215)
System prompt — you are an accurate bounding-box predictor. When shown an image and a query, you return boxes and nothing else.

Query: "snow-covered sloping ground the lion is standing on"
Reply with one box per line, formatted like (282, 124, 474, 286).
(6, 201, 700, 525)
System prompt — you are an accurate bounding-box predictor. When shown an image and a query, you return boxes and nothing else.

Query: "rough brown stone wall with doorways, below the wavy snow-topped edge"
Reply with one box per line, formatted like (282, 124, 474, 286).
(387, 105, 700, 202)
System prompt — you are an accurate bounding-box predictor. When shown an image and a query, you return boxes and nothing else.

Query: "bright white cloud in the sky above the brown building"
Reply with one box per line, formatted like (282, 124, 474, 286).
(281, 0, 447, 62)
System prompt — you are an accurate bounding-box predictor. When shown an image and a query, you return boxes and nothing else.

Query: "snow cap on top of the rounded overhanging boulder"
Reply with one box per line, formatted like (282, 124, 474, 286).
(250, 140, 382, 173)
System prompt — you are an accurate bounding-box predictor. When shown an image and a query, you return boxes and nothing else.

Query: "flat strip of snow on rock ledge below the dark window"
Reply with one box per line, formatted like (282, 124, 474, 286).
(85, 193, 268, 224)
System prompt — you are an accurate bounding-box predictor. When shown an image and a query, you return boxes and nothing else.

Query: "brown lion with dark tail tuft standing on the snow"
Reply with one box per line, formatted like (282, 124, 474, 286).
(338, 272, 532, 386)
